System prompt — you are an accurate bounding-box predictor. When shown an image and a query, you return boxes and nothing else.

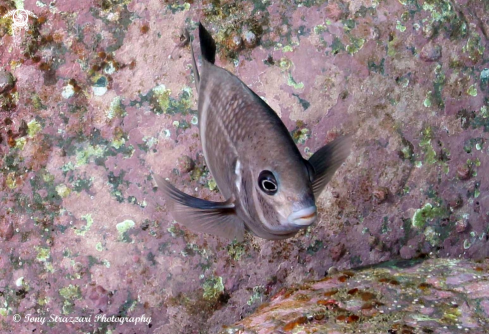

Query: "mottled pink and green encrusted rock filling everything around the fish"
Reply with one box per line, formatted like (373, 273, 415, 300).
(0, 0, 489, 334)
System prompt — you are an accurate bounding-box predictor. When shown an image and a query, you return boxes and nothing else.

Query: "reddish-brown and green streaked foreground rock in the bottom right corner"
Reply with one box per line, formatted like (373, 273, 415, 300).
(221, 259, 489, 334)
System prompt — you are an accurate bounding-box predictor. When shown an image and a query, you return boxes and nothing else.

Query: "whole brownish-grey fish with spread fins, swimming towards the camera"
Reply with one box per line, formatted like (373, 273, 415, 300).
(153, 23, 351, 241)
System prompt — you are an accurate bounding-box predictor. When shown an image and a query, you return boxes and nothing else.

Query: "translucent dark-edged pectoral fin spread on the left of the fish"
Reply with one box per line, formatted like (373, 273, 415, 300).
(153, 175, 244, 241)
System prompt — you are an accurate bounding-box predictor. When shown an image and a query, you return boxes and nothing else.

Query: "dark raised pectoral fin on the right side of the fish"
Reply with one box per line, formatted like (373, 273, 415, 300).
(309, 136, 351, 198)
